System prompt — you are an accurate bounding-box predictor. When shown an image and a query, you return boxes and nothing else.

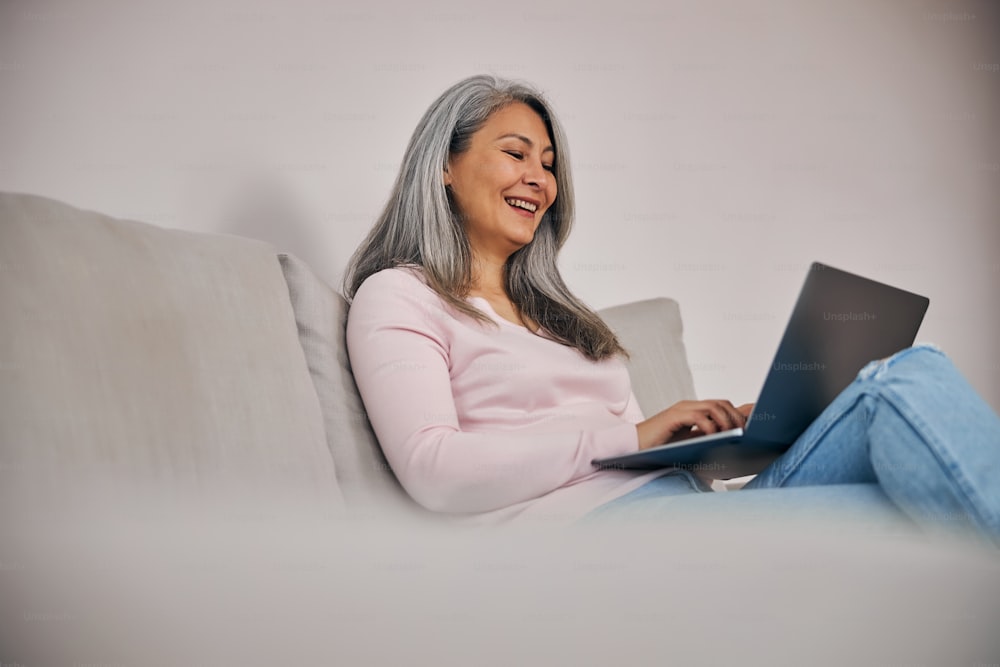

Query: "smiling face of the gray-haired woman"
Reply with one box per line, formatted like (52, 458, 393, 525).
(444, 102, 556, 263)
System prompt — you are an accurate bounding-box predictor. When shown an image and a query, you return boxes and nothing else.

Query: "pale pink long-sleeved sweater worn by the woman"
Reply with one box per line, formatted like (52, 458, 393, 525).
(347, 268, 665, 523)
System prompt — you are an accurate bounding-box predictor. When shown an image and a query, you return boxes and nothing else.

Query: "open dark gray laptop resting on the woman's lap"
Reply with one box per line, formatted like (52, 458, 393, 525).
(592, 262, 930, 479)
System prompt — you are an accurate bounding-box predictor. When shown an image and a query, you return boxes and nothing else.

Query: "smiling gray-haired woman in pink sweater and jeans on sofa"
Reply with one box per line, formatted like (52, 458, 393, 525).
(345, 76, 1000, 539)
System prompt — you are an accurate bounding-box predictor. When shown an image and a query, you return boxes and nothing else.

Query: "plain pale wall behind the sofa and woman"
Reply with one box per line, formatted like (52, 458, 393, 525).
(0, 0, 1000, 409)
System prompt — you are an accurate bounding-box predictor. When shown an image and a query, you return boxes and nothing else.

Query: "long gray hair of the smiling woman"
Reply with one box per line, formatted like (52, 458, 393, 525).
(344, 75, 625, 360)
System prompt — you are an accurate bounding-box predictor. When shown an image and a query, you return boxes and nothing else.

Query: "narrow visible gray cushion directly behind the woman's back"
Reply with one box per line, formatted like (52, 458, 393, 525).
(279, 254, 425, 514)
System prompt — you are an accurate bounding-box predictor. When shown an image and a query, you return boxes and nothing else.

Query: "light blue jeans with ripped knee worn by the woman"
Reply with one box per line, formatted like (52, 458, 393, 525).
(583, 345, 1000, 545)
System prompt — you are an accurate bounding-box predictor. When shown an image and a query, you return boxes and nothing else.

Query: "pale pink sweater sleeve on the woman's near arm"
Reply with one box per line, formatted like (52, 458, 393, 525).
(347, 269, 641, 513)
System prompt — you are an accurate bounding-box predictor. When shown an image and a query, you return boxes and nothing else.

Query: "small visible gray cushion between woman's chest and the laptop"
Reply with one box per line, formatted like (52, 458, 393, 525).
(599, 298, 695, 417)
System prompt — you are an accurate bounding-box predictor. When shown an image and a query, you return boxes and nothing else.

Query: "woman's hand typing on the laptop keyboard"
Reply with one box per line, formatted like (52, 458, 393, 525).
(636, 400, 753, 449)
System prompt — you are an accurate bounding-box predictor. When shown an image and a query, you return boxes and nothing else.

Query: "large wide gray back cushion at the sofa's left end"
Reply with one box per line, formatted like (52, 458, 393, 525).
(0, 194, 343, 511)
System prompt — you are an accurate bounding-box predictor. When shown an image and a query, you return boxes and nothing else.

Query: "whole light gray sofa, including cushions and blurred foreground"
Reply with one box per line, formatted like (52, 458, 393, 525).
(0, 194, 1000, 665)
